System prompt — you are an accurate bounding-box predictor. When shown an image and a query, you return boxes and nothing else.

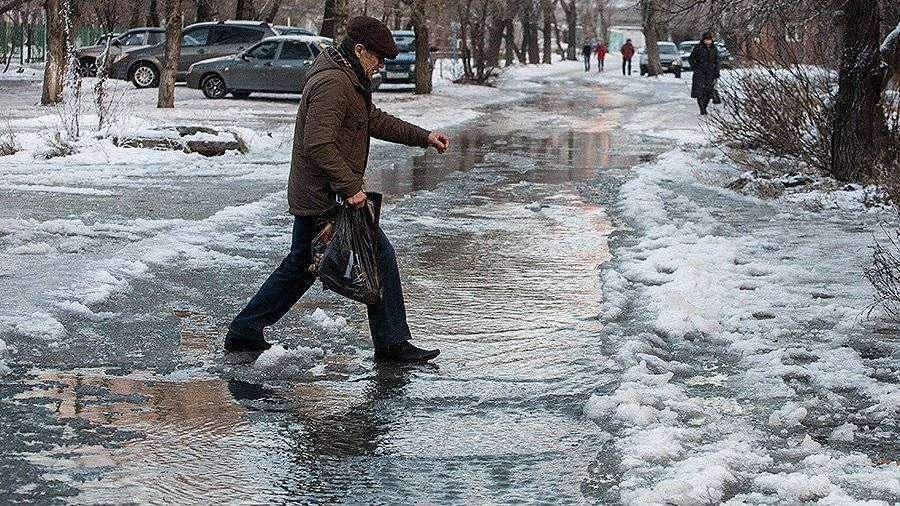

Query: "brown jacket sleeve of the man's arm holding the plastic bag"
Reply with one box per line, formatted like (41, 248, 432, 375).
(301, 75, 363, 198)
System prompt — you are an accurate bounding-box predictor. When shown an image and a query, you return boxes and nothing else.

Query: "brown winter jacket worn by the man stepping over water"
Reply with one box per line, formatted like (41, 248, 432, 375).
(288, 45, 428, 216)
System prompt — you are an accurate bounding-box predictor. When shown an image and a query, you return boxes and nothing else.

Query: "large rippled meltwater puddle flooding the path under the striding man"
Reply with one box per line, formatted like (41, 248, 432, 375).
(0, 75, 676, 503)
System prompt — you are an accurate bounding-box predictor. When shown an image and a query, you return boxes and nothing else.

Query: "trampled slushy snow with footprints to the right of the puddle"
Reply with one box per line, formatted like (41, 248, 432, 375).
(585, 147, 900, 504)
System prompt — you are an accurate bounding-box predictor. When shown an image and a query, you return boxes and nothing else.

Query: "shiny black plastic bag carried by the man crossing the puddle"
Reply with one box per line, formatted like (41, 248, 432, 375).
(312, 193, 381, 305)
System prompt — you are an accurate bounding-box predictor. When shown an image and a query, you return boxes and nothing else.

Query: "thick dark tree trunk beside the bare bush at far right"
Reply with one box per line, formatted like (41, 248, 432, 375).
(831, 0, 885, 181)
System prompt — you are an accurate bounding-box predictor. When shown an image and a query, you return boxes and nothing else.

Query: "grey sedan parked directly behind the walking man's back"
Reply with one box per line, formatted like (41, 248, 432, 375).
(187, 35, 380, 98)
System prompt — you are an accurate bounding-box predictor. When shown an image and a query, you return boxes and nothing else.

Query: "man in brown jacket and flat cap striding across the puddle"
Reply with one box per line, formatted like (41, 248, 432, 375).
(225, 17, 450, 362)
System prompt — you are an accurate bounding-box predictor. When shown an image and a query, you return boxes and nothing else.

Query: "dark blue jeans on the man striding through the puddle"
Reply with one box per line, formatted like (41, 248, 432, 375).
(231, 216, 410, 349)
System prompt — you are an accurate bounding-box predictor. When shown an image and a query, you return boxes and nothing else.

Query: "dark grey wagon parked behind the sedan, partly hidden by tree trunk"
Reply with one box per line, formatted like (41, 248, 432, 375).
(112, 21, 277, 88)
